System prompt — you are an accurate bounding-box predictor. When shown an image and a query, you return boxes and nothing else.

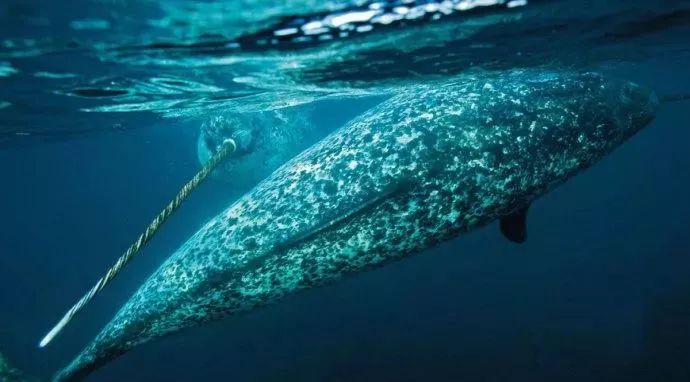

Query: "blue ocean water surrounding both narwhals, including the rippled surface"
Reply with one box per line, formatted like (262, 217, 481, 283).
(0, 0, 690, 381)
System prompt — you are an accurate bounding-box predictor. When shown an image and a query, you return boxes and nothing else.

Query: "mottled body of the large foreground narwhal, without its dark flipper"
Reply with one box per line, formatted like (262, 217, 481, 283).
(57, 71, 656, 380)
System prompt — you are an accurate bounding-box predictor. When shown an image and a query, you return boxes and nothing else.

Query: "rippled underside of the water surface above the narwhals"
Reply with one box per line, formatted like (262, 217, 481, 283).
(0, 0, 690, 146)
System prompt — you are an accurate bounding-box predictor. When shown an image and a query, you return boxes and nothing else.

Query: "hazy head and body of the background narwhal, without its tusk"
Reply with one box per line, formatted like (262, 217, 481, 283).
(197, 108, 325, 192)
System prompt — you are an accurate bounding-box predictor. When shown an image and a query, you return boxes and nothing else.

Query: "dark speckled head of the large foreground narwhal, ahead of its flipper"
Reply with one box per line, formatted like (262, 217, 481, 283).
(478, 71, 658, 188)
